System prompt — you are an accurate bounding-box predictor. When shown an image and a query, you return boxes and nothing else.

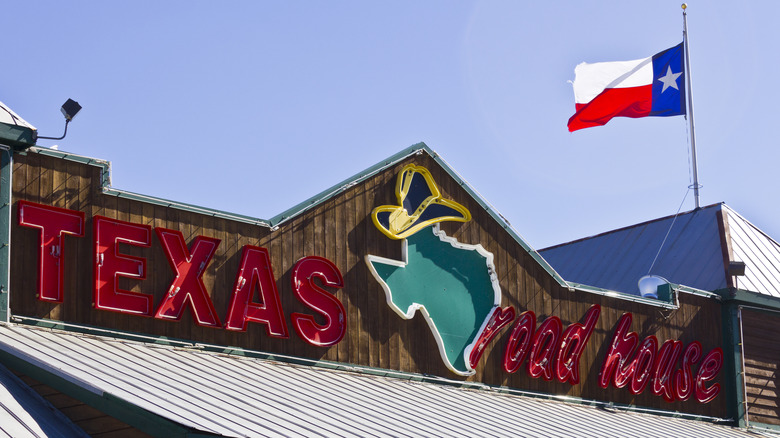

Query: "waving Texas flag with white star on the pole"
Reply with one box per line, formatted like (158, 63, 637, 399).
(568, 43, 685, 132)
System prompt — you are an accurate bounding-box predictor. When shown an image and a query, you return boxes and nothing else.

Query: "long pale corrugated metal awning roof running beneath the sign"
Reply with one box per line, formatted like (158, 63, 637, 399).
(0, 325, 755, 438)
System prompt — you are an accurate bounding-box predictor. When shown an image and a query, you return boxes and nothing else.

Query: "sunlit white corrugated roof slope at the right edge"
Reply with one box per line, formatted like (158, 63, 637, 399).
(723, 205, 780, 297)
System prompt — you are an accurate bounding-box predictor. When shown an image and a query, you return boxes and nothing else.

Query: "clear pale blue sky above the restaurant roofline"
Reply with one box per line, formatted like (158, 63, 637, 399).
(0, 0, 780, 248)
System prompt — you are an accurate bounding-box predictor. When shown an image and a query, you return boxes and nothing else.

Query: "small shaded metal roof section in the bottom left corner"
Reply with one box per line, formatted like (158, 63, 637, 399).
(0, 365, 89, 438)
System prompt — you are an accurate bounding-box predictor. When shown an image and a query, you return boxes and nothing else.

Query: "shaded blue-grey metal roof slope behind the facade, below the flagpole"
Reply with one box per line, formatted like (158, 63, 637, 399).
(539, 204, 726, 295)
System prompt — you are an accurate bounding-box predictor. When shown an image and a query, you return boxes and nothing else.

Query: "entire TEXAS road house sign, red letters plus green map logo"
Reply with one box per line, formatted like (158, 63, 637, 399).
(12, 164, 723, 403)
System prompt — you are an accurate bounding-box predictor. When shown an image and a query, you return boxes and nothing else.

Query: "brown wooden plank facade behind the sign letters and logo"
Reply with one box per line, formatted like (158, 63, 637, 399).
(10, 145, 730, 418)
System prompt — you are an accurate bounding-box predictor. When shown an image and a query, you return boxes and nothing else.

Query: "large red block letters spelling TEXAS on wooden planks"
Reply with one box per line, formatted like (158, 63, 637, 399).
(18, 201, 346, 346)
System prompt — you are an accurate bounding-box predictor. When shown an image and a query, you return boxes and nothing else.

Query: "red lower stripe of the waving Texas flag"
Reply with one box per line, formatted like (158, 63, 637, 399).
(568, 85, 653, 132)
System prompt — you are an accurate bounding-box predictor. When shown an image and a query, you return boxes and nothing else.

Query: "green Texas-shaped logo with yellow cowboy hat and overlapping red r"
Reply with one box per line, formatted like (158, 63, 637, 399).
(366, 164, 514, 376)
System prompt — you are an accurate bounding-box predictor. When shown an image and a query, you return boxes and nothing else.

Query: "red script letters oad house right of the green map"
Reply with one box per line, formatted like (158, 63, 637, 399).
(504, 304, 723, 403)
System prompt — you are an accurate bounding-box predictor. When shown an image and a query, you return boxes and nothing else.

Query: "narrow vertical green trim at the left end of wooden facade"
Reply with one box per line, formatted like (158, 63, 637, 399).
(0, 145, 13, 322)
